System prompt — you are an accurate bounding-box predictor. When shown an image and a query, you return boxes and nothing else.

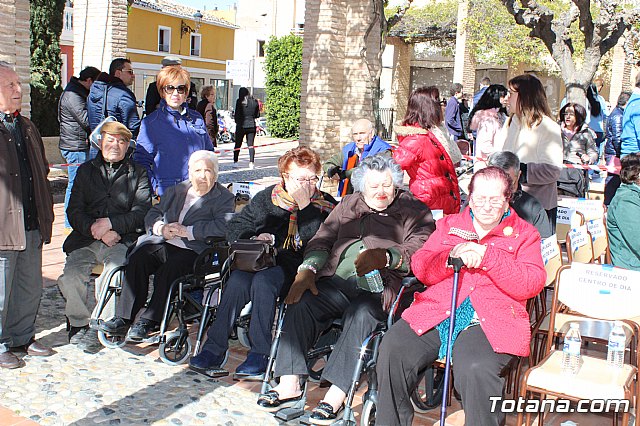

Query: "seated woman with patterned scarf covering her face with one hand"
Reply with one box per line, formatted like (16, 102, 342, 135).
(189, 147, 336, 377)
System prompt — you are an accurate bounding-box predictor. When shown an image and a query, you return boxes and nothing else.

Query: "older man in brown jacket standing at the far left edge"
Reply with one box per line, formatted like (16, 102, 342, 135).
(0, 61, 53, 368)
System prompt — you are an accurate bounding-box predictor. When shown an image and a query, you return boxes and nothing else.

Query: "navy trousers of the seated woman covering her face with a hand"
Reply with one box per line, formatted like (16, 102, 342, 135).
(202, 266, 284, 355)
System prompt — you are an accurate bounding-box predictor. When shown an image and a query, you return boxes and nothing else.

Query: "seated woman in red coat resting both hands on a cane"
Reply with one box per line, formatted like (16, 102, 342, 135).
(376, 167, 546, 425)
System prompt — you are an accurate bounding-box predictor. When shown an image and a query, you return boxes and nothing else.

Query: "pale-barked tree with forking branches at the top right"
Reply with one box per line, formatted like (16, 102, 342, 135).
(500, 0, 640, 103)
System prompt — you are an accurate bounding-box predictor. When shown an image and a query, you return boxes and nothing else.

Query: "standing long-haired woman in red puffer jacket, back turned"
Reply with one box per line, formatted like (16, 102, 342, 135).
(393, 87, 460, 214)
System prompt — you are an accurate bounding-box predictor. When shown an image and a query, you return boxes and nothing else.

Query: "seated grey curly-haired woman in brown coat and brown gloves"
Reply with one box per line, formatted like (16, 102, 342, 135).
(258, 155, 435, 424)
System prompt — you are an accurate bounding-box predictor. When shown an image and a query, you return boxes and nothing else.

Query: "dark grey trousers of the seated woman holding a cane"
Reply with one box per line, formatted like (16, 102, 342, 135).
(376, 319, 513, 426)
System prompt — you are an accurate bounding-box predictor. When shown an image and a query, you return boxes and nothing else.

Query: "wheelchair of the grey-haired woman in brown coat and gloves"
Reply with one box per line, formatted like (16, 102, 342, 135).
(260, 278, 422, 426)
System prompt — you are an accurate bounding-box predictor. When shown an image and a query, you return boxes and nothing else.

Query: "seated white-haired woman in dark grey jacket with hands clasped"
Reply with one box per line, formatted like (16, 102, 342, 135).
(98, 150, 234, 342)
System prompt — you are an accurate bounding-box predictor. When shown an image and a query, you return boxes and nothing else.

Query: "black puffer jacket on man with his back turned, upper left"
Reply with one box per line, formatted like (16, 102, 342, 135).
(58, 77, 91, 151)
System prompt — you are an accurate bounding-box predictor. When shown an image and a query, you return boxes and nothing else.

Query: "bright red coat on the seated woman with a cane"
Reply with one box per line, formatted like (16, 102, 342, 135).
(402, 207, 546, 356)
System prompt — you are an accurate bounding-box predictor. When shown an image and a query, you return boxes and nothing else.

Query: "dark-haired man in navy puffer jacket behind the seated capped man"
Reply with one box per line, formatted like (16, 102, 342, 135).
(87, 58, 140, 146)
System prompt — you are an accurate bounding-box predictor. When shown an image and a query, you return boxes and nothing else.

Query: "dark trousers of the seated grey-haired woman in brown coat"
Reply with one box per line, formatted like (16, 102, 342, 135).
(275, 276, 385, 392)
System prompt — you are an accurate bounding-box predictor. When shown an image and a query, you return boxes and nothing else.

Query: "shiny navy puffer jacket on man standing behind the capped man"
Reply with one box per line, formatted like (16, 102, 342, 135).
(87, 73, 140, 139)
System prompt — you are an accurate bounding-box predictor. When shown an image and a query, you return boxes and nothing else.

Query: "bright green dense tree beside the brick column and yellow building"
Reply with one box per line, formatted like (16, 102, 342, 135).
(264, 35, 302, 138)
